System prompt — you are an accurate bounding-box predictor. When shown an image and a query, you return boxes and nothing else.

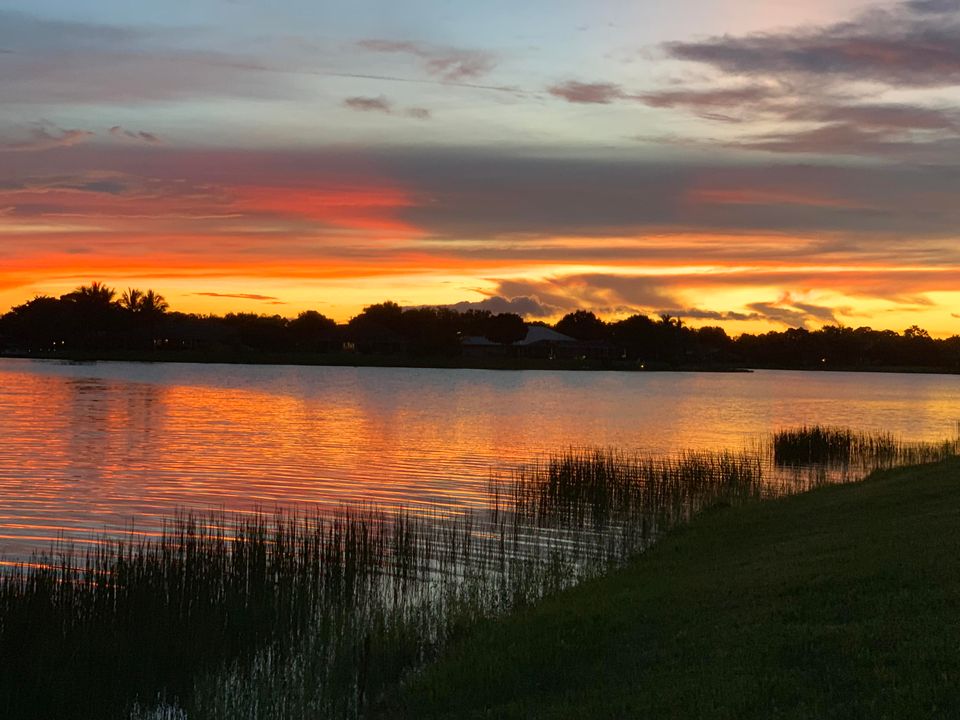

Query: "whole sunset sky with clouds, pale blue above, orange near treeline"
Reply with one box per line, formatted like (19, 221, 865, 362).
(0, 0, 960, 336)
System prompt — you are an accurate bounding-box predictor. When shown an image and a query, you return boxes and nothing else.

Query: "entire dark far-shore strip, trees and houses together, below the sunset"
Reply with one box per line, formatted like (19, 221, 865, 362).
(0, 283, 960, 372)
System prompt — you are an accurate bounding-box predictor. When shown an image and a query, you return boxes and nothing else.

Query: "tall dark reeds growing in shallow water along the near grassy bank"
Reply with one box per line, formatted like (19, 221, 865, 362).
(0, 428, 960, 720)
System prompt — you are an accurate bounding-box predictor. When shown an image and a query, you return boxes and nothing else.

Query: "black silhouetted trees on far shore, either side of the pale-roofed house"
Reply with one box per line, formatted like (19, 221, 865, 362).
(0, 282, 960, 370)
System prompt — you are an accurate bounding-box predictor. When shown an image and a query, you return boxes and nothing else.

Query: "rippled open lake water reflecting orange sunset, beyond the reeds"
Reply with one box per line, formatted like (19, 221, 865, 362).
(0, 360, 960, 558)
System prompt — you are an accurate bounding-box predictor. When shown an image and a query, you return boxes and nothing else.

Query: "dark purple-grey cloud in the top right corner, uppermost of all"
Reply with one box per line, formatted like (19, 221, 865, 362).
(665, 0, 960, 87)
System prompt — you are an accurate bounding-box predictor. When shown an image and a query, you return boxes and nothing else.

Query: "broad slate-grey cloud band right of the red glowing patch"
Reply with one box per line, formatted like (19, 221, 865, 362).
(372, 148, 960, 240)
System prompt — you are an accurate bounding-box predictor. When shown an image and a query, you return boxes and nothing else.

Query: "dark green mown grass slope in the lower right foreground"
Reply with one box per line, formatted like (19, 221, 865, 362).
(382, 458, 960, 718)
